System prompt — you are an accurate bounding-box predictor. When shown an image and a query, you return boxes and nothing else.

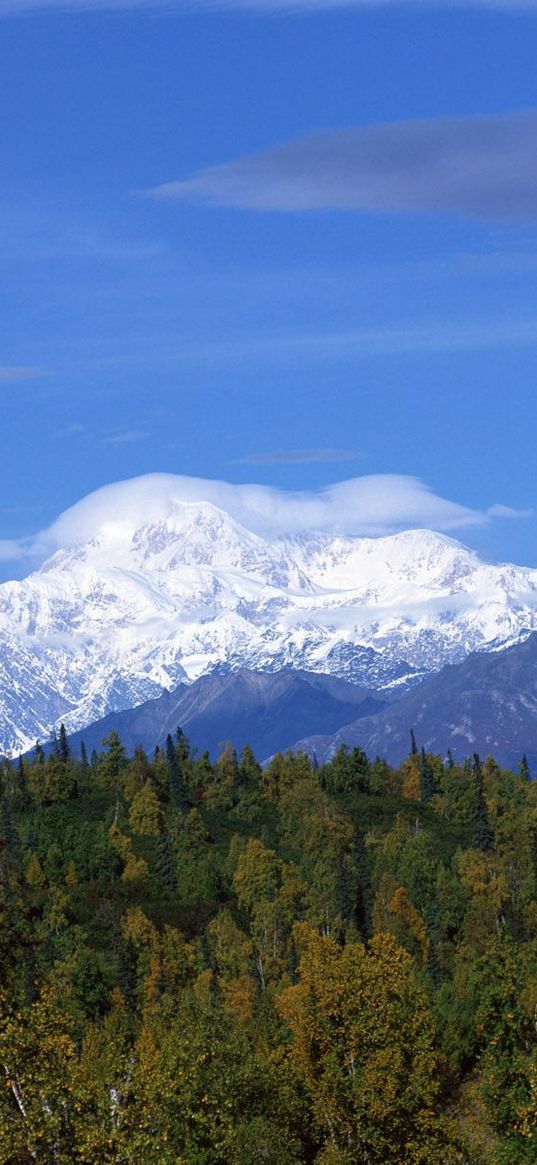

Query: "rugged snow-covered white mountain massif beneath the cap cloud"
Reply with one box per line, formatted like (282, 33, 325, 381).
(0, 478, 537, 750)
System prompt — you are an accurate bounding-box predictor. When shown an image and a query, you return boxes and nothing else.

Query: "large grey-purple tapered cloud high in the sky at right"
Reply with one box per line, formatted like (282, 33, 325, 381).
(148, 112, 537, 220)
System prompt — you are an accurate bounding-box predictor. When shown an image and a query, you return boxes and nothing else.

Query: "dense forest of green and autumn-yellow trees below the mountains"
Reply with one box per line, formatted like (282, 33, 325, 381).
(0, 729, 537, 1165)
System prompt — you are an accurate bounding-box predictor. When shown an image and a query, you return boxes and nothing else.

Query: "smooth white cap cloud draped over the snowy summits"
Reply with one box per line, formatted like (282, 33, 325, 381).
(0, 473, 526, 562)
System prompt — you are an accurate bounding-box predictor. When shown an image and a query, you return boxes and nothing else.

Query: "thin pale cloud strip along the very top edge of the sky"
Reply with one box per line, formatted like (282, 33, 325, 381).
(0, 0, 537, 16)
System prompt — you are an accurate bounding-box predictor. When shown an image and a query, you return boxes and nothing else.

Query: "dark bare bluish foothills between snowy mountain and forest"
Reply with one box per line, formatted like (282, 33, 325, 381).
(53, 633, 537, 771)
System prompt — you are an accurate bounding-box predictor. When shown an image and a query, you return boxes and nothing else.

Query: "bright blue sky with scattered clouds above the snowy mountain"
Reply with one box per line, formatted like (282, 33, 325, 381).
(0, 0, 537, 578)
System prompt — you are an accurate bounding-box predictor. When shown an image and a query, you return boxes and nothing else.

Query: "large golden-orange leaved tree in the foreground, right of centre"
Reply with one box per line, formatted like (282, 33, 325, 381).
(280, 923, 461, 1165)
